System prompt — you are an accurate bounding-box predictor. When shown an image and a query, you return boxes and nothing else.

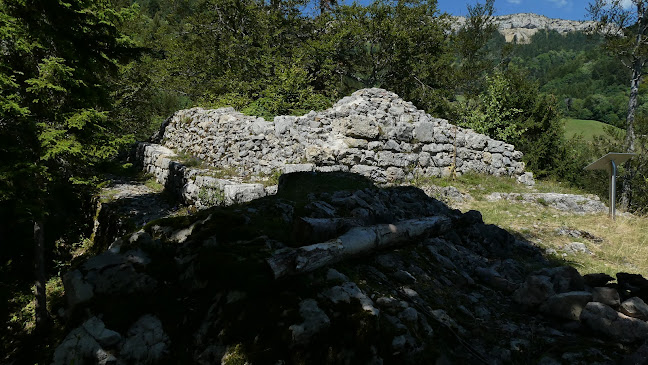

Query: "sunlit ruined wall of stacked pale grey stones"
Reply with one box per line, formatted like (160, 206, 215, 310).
(137, 88, 533, 203)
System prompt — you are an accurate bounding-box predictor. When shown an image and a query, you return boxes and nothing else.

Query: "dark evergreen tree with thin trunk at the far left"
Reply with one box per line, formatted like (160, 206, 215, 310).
(0, 0, 134, 327)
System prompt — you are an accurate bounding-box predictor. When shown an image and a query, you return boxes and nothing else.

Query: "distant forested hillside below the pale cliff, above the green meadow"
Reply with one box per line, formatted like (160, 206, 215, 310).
(504, 30, 636, 128)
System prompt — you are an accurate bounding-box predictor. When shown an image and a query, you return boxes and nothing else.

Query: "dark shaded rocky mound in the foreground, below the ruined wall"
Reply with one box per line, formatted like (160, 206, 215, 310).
(54, 172, 648, 364)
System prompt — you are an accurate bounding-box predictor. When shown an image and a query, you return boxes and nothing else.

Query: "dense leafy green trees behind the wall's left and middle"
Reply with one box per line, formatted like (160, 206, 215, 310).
(110, 0, 453, 123)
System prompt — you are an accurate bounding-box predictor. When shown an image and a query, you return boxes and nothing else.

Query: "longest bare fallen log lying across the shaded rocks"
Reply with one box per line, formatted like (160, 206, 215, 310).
(266, 216, 451, 279)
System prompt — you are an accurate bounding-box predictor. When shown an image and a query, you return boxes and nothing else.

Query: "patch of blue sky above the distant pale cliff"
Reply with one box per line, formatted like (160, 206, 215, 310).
(438, 0, 604, 20)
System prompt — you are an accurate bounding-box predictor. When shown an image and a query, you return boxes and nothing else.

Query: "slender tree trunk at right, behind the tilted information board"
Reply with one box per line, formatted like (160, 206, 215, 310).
(619, 57, 642, 210)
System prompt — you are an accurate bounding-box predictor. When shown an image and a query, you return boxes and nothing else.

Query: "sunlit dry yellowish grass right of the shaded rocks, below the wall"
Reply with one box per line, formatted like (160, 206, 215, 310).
(416, 176, 648, 277)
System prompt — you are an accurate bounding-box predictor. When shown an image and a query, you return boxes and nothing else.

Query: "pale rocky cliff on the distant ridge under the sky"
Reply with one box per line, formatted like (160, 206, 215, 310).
(452, 13, 596, 43)
